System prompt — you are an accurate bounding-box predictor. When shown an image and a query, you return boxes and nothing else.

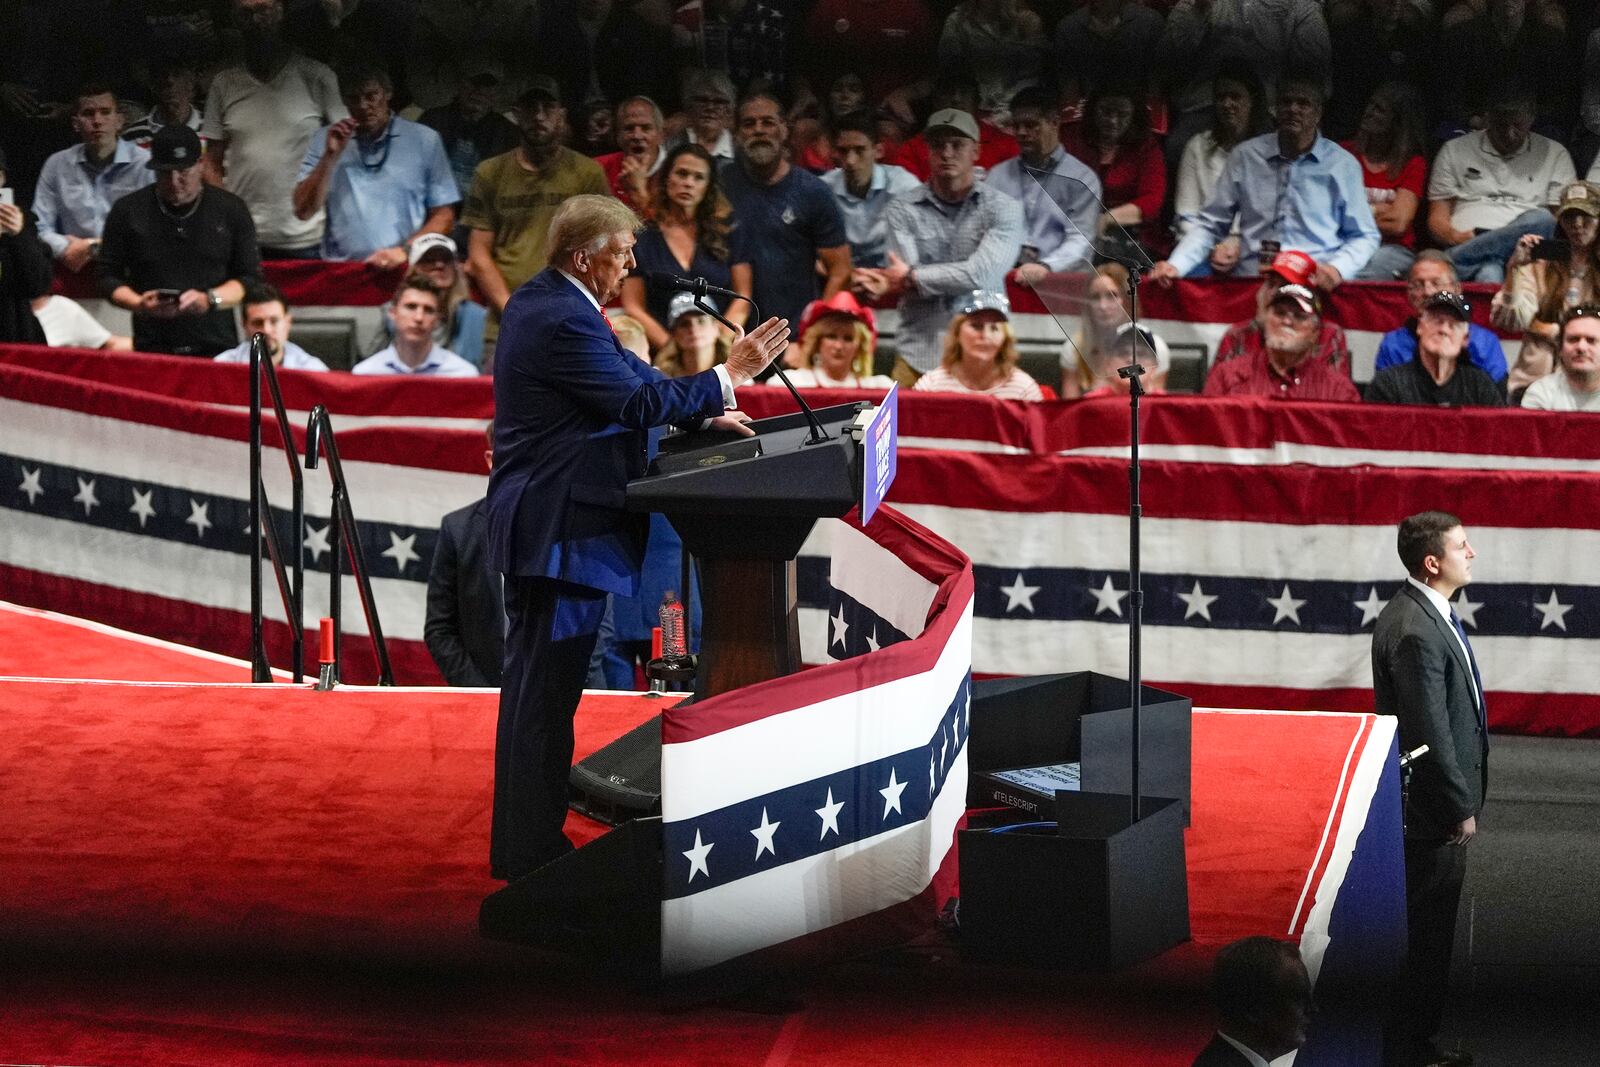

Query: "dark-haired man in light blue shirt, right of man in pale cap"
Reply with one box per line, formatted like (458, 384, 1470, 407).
(984, 88, 1101, 285)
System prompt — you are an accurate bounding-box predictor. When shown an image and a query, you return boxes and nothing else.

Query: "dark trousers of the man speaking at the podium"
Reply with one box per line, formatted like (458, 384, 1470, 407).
(490, 576, 595, 881)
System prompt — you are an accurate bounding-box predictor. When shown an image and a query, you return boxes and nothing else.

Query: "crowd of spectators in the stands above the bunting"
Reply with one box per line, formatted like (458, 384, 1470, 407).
(0, 0, 1600, 406)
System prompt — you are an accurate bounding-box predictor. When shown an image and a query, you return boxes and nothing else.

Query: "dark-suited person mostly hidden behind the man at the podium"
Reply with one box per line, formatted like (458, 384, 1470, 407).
(422, 422, 506, 686)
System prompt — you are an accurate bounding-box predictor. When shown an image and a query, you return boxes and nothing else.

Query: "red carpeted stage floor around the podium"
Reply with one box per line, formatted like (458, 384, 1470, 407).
(0, 609, 1398, 1064)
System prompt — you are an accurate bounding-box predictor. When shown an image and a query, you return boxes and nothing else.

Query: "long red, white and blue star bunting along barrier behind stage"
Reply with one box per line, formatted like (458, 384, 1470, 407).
(0, 347, 1600, 739)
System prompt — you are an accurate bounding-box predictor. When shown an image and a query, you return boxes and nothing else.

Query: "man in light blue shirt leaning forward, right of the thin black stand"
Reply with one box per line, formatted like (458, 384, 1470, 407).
(1150, 78, 1382, 291)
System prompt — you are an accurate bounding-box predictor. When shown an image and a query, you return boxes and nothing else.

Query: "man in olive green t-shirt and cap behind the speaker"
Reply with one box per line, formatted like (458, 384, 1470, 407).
(461, 77, 611, 355)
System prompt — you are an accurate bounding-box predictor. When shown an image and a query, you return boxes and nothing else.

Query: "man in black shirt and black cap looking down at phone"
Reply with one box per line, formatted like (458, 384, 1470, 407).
(99, 126, 261, 357)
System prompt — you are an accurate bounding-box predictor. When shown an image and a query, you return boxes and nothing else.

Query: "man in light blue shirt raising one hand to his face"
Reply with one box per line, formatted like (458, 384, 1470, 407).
(294, 67, 461, 270)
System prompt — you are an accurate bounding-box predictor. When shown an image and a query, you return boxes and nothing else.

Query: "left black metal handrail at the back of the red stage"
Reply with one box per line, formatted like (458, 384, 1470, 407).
(250, 333, 306, 683)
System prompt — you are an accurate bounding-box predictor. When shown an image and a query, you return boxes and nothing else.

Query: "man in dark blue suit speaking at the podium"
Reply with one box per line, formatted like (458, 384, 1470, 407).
(488, 195, 789, 881)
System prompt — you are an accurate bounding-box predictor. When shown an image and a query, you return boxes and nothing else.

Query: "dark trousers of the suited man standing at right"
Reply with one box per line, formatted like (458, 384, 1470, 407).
(1384, 838, 1467, 1065)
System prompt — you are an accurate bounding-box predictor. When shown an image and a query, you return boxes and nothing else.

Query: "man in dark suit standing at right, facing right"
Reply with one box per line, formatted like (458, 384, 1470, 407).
(1373, 512, 1490, 1067)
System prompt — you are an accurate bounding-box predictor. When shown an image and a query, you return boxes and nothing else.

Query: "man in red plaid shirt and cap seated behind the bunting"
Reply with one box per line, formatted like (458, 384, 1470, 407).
(1203, 285, 1362, 400)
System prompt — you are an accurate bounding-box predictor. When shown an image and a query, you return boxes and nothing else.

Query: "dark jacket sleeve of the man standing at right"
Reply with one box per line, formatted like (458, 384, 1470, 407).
(1390, 622, 1475, 825)
